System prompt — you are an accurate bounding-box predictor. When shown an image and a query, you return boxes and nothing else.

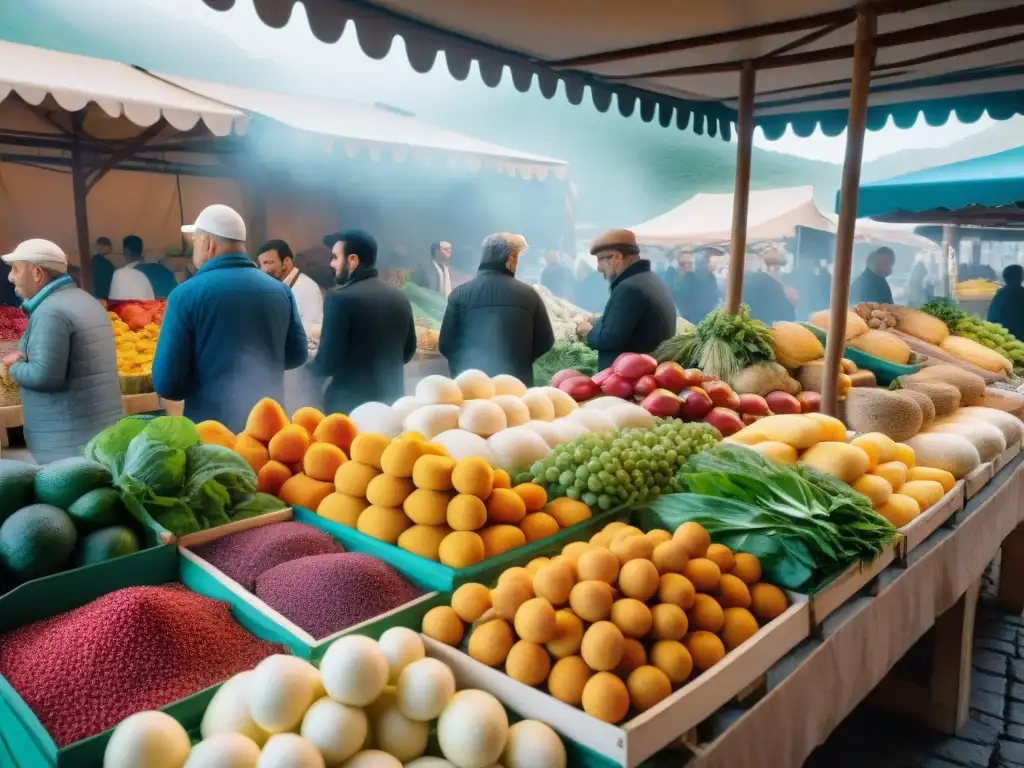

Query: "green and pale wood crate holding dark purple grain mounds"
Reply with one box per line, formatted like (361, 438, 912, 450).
(177, 509, 442, 659)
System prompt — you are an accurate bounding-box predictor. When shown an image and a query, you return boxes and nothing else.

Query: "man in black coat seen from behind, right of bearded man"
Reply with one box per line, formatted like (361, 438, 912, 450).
(437, 233, 555, 386)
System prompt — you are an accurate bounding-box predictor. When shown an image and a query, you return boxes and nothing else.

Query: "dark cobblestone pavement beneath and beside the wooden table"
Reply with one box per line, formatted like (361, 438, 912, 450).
(804, 564, 1024, 768)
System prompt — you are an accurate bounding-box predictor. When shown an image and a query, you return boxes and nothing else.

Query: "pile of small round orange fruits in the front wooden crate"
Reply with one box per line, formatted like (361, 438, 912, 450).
(422, 519, 788, 723)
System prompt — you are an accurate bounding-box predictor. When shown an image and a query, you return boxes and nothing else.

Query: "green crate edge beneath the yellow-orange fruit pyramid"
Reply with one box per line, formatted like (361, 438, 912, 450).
(295, 507, 624, 592)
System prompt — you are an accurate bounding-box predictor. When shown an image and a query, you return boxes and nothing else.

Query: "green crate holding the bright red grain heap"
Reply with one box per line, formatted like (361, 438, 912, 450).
(0, 546, 287, 768)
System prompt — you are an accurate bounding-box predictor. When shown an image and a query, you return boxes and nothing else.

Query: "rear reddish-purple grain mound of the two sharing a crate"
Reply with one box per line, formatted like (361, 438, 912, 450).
(193, 521, 344, 592)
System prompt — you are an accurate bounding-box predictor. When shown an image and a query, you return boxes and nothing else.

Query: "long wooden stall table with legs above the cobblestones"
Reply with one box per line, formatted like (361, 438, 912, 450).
(680, 455, 1024, 768)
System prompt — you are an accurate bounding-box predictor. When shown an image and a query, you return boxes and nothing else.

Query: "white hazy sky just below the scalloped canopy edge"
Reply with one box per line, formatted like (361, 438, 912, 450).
(139, 0, 992, 164)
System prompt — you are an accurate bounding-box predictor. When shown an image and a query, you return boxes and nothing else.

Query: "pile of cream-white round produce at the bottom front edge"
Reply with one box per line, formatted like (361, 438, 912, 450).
(103, 627, 567, 768)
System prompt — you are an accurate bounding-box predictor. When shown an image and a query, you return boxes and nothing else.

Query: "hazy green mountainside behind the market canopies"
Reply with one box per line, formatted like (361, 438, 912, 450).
(0, 0, 1024, 226)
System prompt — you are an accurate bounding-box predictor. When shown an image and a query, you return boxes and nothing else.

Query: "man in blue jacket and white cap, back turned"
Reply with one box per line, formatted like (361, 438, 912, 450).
(153, 205, 307, 432)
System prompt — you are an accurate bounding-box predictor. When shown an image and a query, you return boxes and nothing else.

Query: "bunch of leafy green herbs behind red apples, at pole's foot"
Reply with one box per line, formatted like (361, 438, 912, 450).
(654, 304, 775, 381)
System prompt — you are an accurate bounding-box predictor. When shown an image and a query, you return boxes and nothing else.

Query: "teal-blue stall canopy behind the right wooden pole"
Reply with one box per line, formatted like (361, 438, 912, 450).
(851, 146, 1024, 223)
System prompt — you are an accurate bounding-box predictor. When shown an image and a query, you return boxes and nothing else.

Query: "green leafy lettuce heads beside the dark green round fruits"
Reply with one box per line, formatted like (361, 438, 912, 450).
(83, 416, 284, 536)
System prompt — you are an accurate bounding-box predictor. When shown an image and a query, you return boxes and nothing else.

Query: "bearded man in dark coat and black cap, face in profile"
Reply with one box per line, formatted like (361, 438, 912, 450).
(312, 229, 416, 414)
